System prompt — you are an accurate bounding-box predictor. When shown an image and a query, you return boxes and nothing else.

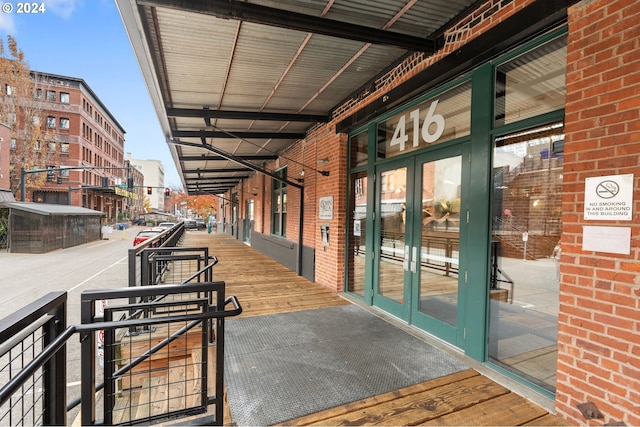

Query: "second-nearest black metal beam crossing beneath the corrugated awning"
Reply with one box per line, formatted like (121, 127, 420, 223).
(167, 107, 329, 123)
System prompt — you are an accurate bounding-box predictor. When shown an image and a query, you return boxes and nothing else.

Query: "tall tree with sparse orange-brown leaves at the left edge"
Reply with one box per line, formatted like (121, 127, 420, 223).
(0, 36, 55, 199)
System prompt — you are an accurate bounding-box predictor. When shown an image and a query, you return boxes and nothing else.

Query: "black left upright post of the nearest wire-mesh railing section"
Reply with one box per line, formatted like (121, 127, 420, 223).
(80, 296, 96, 426)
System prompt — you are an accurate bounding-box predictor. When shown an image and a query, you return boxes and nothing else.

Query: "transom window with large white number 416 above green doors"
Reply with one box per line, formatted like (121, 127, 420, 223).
(378, 82, 471, 159)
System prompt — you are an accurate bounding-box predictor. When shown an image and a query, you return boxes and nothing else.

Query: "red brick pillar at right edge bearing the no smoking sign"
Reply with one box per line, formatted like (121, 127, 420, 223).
(556, 0, 640, 425)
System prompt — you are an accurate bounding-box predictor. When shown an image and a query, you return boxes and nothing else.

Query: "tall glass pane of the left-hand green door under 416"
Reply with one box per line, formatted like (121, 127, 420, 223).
(377, 166, 409, 304)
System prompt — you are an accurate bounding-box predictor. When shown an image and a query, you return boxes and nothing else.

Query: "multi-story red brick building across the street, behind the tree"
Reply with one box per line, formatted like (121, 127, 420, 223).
(12, 72, 140, 222)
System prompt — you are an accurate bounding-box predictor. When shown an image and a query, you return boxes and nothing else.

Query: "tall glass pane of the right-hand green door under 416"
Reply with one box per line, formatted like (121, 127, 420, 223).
(413, 156, 462, 326)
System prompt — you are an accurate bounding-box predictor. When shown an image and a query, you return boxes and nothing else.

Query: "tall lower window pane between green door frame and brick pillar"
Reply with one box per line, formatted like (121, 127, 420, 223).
(489, 123, 564, 391)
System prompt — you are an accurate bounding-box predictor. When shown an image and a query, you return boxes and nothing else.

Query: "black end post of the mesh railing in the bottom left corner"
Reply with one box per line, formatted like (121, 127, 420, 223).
(43, 293, 67, 426)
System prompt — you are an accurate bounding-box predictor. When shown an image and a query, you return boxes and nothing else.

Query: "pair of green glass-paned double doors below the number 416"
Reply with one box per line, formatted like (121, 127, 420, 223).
(373, 144, 469, 347)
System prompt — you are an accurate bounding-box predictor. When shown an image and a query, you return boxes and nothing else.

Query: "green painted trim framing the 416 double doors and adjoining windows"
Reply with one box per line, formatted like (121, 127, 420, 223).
(345, 25, 568, 398)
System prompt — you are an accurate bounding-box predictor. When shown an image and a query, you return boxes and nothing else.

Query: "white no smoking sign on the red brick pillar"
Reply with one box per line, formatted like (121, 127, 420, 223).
(584, 174, 633, 221)
